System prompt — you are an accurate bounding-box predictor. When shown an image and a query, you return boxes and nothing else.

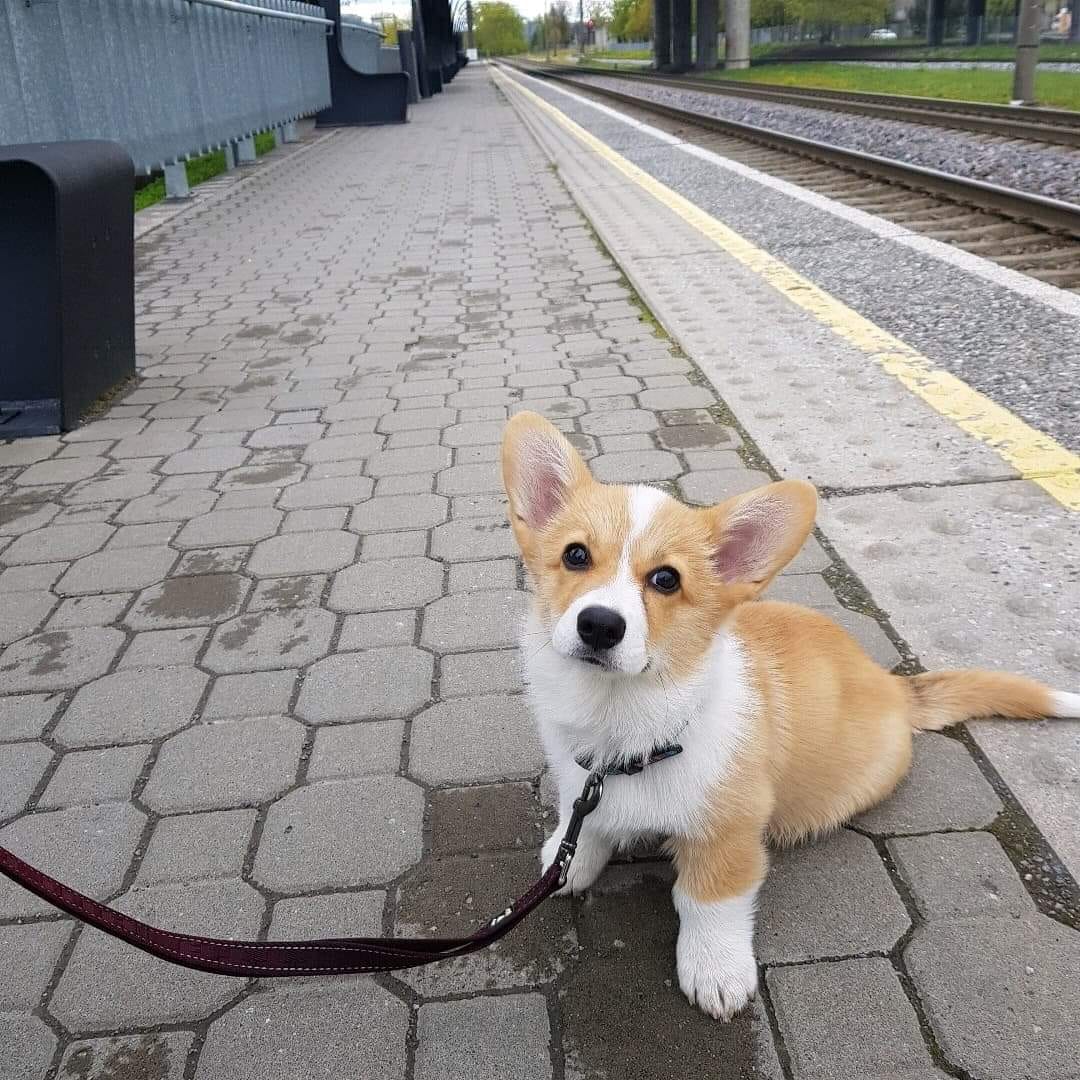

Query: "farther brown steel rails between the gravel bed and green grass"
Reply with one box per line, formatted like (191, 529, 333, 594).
(548, 67, 1080, 147)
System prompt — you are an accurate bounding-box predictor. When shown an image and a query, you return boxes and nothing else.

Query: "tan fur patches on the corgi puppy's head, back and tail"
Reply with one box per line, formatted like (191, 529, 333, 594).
(502, 414, 1067, 902)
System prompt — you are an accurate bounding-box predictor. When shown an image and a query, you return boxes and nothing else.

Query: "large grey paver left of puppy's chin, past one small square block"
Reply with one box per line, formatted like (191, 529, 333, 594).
(296, 646, 434, 724)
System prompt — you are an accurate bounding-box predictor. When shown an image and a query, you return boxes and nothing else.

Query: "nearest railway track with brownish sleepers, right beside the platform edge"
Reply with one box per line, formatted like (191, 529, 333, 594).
(510, 63, 1080, 293)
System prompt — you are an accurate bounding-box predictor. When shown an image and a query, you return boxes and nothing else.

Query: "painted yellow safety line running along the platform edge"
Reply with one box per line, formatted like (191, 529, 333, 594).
(499, 65, 1080, 511)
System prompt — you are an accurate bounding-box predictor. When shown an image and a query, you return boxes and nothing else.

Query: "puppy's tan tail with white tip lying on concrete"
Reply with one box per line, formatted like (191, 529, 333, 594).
(903, 671, 1080, 731)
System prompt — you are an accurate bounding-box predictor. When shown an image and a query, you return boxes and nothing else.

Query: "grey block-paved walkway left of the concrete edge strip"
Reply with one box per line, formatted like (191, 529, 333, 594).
(0, 68, 1080, 1080)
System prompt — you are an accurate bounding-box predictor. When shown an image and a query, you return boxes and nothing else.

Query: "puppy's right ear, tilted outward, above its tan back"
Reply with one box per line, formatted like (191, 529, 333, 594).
(707, 480, 818, 595)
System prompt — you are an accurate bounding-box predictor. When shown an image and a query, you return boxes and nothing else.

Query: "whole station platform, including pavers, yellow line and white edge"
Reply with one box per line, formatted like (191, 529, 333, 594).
(0, 65, 1080, 1080)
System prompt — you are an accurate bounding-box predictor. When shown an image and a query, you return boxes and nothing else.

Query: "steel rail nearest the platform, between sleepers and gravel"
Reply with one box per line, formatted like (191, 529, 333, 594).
(512, 64, 1080, 238)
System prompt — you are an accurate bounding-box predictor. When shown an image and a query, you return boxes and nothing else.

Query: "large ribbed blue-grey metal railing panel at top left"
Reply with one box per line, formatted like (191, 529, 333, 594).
(0, 0, 333, 172)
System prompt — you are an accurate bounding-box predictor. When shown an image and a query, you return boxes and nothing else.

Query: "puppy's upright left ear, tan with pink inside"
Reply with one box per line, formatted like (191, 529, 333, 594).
(502, 413, 591, 531)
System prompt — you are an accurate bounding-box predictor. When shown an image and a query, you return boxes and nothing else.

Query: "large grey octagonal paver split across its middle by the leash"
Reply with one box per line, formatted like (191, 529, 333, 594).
(50, 879, 265, 1031)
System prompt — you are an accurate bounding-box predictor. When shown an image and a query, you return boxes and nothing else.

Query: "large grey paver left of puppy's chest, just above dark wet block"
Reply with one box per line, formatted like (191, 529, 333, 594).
(409, 694, 543, 784)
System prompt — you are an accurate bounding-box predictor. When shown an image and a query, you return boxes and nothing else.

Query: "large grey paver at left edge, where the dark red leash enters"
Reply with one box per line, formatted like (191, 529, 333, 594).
(0, 802, 146, 918)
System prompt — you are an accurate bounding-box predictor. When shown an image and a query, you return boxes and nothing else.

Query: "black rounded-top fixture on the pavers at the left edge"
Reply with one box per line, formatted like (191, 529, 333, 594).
(0, 140, 135, 440)
